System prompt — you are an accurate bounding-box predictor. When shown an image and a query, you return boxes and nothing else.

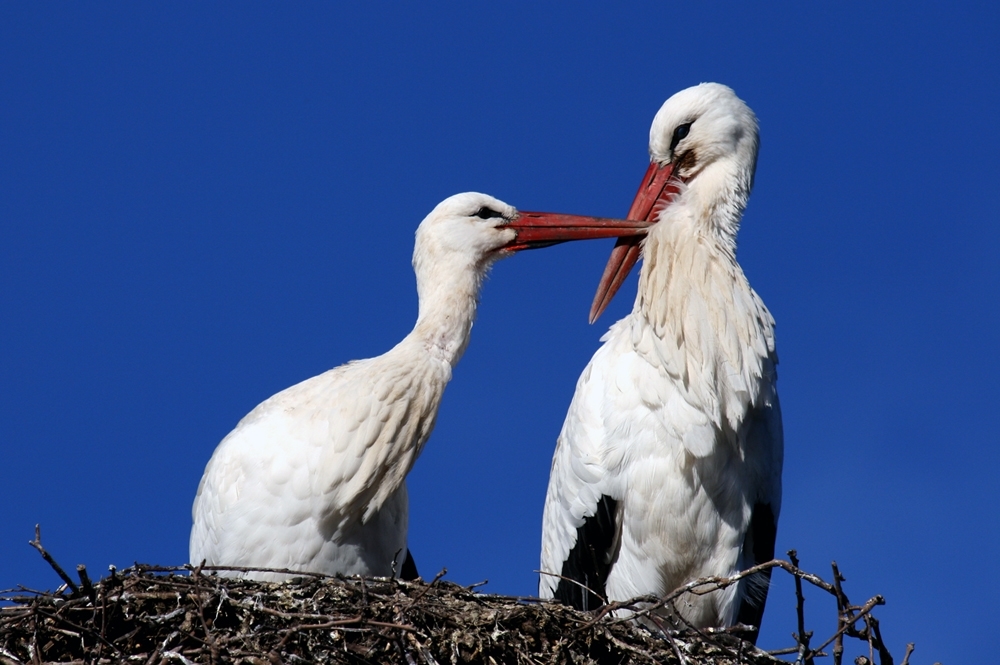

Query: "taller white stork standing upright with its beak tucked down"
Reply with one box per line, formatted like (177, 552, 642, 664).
(539, 83, 783, 638)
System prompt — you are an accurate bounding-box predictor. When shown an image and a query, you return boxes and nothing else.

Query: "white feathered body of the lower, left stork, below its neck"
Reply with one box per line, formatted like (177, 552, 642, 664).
(190, 330, 446, 579)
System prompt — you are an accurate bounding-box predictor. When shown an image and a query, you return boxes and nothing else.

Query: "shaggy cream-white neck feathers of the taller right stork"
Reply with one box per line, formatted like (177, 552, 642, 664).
(630, 161, 777, 431)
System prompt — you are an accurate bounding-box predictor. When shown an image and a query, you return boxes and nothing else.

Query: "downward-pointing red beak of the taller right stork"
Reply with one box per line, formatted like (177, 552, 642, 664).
(590, 162, 678, 323)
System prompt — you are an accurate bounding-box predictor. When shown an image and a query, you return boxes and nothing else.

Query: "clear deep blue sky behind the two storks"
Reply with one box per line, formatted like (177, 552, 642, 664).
(0, 2, 1000, 663)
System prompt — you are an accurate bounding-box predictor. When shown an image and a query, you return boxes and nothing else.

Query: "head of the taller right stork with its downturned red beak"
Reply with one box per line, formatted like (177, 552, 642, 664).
(590, 83, 759, 323)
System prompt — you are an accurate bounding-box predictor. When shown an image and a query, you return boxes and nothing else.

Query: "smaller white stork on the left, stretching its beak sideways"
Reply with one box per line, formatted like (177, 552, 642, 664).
(190, 193, 648, 580)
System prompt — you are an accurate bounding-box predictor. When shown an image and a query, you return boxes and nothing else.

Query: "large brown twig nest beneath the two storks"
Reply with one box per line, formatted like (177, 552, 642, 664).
(0, 565, 782, 665)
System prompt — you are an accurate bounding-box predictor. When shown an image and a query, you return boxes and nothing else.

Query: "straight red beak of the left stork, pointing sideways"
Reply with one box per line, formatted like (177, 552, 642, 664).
(502, 210, 652, 252)
